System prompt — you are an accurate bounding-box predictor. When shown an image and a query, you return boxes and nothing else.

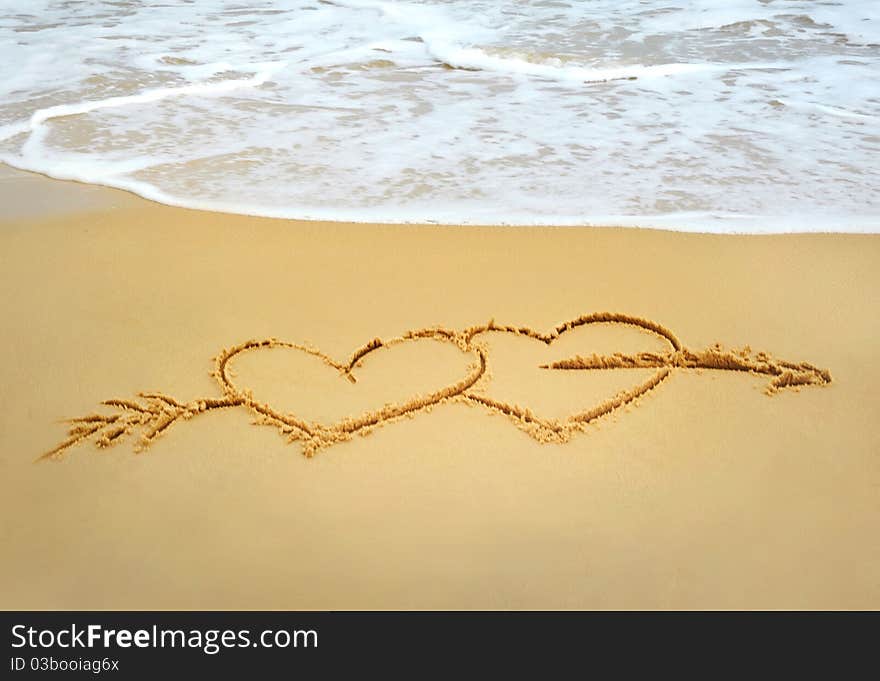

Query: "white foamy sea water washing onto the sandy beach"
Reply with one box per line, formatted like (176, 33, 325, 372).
(0, 0, 880, 232)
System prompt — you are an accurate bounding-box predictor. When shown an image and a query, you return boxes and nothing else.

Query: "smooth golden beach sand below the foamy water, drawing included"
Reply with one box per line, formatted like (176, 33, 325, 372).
(0, 171, 880, 608)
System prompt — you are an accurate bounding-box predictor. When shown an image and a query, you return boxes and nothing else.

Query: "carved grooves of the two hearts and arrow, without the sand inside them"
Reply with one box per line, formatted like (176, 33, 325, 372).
(40, 312, 831, 459)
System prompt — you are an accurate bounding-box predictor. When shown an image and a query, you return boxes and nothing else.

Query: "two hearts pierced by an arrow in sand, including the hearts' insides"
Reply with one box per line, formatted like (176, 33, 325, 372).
(39, 312, 831, 459)
